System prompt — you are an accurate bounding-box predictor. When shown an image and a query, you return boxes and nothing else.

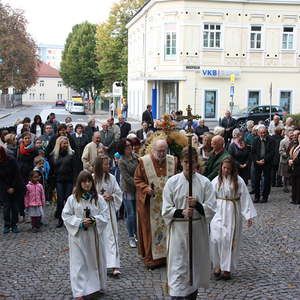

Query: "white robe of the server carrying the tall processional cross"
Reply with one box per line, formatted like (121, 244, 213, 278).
(162, 173, 216, 297)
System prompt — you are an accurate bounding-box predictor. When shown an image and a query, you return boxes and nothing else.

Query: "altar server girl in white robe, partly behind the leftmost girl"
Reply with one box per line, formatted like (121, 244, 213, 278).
(94, 156, 122, 276)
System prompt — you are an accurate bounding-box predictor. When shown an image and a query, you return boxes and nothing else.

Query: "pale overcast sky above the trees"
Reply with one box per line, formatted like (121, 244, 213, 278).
(2, 0, 118, 45)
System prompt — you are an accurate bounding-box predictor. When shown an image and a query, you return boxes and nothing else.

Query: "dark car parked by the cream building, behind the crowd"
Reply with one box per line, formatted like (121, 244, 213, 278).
(232, 105, 285, 127)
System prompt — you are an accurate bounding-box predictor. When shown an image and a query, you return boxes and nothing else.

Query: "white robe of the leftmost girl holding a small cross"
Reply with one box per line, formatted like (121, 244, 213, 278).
(62, 195, 109, 297)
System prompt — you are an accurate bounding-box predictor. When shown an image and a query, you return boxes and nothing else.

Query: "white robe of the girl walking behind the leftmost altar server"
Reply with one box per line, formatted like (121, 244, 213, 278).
(96, 174, 122, 268)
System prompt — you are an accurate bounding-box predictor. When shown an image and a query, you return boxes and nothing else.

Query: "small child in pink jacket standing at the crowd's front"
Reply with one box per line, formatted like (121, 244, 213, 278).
(24, 171, 45, 232)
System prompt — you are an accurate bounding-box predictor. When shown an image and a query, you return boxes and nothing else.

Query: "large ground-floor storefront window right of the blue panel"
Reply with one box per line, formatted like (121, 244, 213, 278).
(160, 81, 178, 116)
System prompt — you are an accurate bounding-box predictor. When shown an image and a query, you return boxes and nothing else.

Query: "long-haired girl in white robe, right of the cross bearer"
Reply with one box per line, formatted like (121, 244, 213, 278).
(210, 157, 257, 280)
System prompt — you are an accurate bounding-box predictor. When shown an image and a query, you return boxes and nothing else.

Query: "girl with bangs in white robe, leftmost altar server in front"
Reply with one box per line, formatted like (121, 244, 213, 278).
(62, 171, 109, 300)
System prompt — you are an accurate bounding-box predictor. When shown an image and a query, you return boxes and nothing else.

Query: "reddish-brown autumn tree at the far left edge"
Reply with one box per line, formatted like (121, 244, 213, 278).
(0, 2, 38, 93)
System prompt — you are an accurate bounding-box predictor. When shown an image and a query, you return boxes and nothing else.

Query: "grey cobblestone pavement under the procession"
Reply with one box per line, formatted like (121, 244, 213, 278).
(0, 188, 300, 300)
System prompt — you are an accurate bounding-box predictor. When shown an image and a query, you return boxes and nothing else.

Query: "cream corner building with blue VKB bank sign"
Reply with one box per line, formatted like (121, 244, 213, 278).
(127, 0, 300, 121)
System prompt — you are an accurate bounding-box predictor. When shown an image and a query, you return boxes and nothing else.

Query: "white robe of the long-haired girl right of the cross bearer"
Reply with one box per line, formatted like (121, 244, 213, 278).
(210, 176, 257, 272)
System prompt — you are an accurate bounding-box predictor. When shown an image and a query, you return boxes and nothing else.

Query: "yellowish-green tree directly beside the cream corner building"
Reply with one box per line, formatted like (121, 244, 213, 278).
(96, 0, 147, 91)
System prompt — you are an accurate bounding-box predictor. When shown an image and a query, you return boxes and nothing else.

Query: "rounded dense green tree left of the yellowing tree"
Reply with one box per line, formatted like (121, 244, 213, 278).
(60, 22, 102, 97)
